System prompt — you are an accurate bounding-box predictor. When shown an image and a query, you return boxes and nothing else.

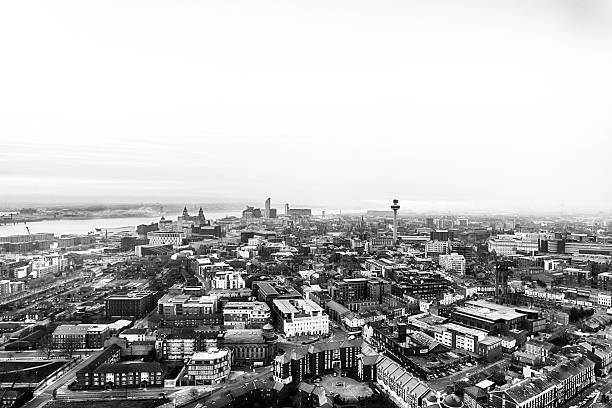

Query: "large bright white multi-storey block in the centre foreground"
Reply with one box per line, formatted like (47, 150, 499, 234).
(273, 299, 329, 337)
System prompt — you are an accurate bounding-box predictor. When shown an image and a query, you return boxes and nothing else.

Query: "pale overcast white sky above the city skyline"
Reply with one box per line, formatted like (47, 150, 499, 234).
(0, 0, 612, 212)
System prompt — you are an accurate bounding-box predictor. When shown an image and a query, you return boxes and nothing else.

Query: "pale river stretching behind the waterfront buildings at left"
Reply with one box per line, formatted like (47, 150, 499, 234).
(0, 211, 242, 237)
